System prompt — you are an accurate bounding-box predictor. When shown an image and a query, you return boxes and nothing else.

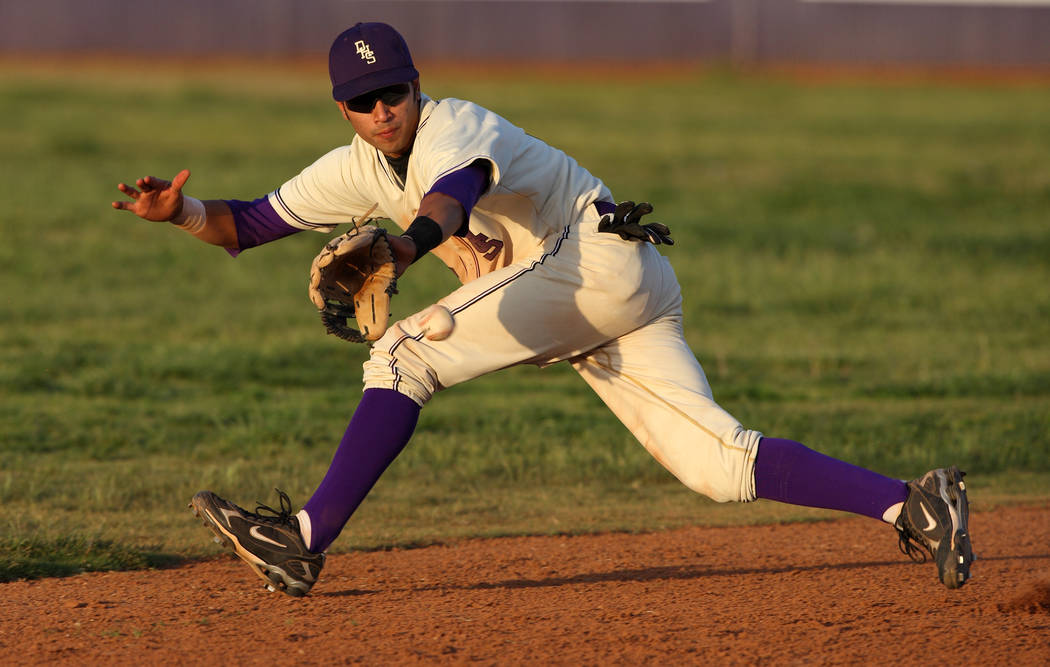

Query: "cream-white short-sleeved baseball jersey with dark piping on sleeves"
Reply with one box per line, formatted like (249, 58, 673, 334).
(270, 97, 612, 283)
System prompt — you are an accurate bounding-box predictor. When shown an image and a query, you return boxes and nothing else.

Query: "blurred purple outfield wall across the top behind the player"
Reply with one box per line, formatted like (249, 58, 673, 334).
(6, 0, 1050, 67)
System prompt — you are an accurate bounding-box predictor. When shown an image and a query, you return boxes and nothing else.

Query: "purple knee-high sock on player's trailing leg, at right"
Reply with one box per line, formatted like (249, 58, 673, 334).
(755, 438, 908, 520)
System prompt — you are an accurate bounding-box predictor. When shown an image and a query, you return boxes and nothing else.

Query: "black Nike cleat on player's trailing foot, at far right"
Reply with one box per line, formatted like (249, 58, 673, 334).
(894, 465, 977, 588)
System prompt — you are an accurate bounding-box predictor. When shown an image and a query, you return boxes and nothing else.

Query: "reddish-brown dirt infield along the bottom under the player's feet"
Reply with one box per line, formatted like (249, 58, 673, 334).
(0, 507, 1050, 666)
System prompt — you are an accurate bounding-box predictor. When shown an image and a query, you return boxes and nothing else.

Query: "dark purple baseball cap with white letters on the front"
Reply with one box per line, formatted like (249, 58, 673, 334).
(329, 23, 419, 102)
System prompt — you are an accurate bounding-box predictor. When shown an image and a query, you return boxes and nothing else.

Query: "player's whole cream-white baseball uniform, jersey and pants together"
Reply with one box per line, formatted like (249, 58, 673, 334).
(270, 92, 761, 501)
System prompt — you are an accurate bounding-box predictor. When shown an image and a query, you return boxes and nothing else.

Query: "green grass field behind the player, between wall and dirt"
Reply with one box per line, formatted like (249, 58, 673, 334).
(0, 63, 1050, 581)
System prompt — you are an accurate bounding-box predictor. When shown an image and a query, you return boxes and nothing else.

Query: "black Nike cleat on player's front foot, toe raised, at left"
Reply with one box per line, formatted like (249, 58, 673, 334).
(190, 489, 324, 598)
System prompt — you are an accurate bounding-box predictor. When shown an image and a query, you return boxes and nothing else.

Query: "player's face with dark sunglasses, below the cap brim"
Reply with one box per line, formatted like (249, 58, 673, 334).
(339, 79, 419, 158)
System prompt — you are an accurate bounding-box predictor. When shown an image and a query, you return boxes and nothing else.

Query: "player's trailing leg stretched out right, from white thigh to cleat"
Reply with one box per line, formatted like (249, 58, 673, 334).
(573, 313, 973, 588)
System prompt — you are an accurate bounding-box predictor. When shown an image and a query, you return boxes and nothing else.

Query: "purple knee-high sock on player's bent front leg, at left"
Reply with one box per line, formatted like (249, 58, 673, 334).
(302, 389, 419, 553)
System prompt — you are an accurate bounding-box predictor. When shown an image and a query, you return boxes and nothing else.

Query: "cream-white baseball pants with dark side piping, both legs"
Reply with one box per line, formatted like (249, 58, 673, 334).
(364, 207, 762, 502)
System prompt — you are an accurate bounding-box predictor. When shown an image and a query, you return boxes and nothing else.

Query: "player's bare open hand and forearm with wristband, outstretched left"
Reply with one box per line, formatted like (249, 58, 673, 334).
(112, 169, 237, 248)
